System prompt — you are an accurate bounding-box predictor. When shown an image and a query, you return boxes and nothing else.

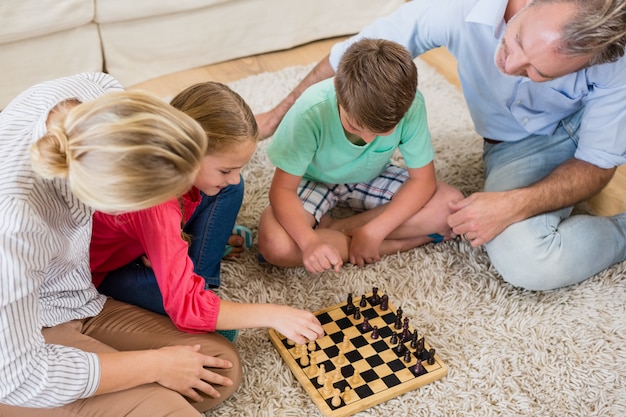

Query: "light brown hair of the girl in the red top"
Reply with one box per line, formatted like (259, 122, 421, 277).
(170, 81, 259, 155)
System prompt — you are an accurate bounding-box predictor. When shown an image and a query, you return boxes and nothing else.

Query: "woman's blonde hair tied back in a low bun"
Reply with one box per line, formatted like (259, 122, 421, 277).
(31, 92, 207, 213)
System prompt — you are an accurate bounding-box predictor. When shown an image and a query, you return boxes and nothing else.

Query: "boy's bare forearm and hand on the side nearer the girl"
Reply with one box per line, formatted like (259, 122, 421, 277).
(269, 168, 342, 272)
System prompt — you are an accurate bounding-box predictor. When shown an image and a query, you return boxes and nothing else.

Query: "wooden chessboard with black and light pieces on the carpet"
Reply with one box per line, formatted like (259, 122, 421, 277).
(269, 288, 448, 417)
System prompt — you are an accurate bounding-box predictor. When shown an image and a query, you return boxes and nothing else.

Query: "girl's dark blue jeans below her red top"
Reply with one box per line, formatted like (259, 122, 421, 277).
(98, 179, 244, 314)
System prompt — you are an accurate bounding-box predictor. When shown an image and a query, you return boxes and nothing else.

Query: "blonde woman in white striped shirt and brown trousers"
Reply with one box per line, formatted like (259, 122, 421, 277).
(0, 73, 241, 417)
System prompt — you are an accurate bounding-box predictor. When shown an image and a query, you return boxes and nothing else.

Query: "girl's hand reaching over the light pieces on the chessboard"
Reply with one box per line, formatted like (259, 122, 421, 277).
(272, 306, 324, 345)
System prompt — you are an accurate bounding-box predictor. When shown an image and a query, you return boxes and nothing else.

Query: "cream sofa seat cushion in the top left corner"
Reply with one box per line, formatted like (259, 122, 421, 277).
(0, 0, 94, 44)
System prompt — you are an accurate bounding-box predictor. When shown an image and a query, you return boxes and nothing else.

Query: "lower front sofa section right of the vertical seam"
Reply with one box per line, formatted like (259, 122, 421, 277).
(100, 0, 404, 87)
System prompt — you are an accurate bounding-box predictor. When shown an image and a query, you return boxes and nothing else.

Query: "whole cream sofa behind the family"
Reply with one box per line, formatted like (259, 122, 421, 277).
(0, 0, 405, 109)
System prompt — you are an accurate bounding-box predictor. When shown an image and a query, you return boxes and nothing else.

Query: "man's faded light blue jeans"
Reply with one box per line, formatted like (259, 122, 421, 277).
(483, 111, 626, 290)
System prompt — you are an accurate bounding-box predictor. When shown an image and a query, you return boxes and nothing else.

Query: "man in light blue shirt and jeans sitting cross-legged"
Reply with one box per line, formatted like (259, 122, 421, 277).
(257, 0, 626, 290)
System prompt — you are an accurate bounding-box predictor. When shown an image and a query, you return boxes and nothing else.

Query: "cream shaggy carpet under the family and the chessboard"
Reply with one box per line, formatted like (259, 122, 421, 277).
(204, 60, 626, 417)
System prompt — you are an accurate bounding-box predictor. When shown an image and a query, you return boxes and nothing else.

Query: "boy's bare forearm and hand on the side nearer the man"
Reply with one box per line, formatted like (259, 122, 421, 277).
(350, 161, 437, 265)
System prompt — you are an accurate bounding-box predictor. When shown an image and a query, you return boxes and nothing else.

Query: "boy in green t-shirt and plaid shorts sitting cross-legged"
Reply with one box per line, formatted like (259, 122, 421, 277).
(259, 39, 463, 273)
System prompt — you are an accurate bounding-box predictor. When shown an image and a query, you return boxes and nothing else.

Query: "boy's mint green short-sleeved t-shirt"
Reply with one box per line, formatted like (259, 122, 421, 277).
(267, 79, 434, 184)
